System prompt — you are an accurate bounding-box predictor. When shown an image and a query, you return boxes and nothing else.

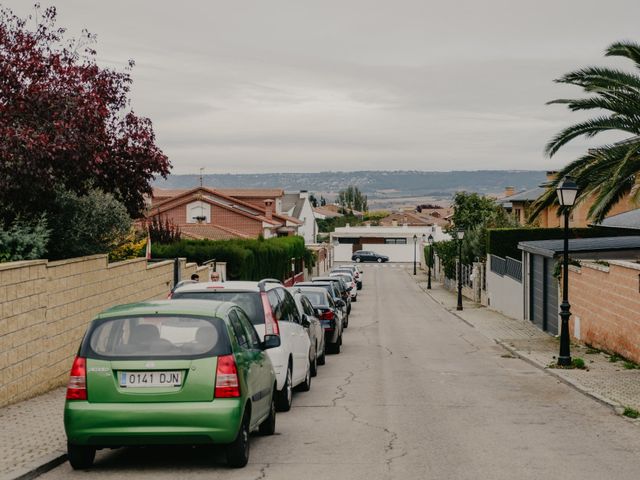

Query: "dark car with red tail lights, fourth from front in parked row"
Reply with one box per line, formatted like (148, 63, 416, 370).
(294, 282, 342, 354)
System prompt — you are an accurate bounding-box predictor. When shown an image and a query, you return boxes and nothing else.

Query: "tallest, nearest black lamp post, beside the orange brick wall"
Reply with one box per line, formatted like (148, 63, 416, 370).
(556, 176, 578, 366)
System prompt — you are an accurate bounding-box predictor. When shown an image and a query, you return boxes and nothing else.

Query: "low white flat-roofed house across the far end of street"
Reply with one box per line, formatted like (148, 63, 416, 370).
(330, 225, 451, 262)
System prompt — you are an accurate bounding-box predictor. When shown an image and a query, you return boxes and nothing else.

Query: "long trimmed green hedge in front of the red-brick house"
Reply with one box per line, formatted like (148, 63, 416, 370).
(151, 236, 314, 281)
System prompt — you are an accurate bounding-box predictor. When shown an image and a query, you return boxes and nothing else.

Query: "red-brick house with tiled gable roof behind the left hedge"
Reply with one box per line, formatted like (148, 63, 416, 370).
(146, 187, 303, 240)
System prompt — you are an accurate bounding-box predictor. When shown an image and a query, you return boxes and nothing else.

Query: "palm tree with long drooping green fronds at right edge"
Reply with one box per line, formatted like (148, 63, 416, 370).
(530, 42, 640, 222)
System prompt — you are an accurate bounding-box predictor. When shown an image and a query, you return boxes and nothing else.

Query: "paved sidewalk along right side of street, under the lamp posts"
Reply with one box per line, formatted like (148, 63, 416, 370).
(418, 280, 640, 414)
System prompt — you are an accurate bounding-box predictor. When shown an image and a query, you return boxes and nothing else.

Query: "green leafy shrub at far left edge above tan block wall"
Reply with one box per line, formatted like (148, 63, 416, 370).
(0, 215, 49, 262)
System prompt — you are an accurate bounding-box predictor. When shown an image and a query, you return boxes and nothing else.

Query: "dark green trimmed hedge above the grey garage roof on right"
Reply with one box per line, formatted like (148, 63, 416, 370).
(487, 228, 638, 259)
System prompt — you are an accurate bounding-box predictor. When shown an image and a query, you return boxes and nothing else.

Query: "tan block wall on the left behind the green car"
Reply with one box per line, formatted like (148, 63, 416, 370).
(0, 255, 206, 406)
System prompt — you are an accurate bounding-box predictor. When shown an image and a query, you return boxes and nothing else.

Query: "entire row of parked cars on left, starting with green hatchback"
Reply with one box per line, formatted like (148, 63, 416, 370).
(64, 265, 362, 469)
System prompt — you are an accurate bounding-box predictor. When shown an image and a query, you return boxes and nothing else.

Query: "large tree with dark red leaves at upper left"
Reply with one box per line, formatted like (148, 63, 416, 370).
(0, 5, 171, 222)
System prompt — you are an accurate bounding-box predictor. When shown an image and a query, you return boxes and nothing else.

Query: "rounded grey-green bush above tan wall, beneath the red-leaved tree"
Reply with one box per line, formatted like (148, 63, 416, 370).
(48, 190, 131, 260)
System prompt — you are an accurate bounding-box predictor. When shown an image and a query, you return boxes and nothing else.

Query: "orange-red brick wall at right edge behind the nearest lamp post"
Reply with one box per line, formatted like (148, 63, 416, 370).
(569, 260, 640, 363)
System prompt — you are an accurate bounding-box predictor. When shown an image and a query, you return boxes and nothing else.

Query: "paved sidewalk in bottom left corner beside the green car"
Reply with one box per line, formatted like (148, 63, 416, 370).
(0, 388, 67, 480)
